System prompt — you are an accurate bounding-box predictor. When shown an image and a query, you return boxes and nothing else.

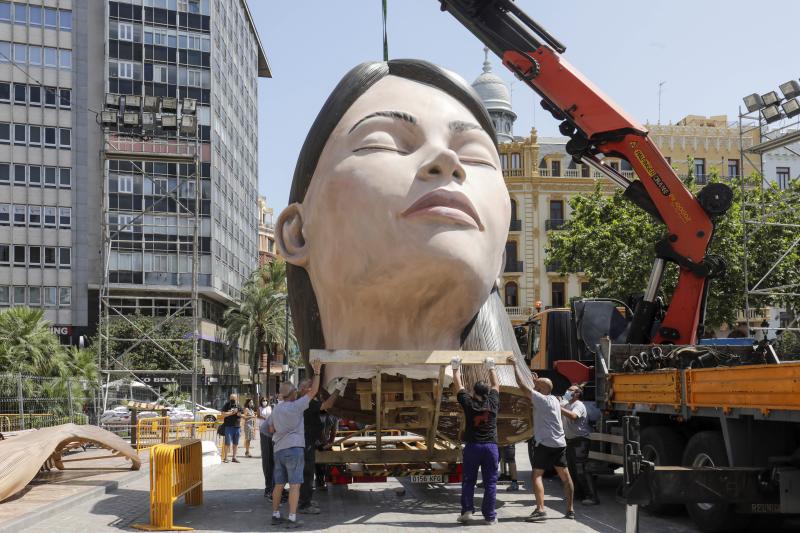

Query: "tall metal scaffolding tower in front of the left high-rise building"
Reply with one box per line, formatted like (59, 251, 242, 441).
(97, 118, 207, 416)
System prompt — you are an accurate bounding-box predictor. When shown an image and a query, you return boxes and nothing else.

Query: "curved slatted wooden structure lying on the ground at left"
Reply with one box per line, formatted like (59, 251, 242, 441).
(0, 424, 142, 502)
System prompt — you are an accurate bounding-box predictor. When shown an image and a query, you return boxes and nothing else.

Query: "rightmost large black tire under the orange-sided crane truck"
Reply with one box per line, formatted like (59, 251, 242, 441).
(683, 431, 750, 533)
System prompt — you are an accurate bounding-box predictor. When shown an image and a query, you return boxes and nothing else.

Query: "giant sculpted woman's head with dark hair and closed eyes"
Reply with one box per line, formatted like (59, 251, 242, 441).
(276, 60, 513, 378)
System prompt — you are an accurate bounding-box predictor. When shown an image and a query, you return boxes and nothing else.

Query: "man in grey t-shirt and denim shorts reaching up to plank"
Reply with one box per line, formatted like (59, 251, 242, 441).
(269, 359, 322, 529)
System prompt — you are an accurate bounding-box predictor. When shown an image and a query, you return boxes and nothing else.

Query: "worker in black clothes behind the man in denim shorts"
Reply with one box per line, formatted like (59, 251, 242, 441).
(297, 378, 347, 514)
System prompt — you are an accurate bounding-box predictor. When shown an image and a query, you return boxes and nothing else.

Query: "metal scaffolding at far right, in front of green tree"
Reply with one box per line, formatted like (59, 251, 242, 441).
(739, 107, 800, 336)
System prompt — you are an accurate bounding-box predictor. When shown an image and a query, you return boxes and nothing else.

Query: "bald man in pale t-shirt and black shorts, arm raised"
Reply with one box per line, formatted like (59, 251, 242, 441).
(509, 356, 575, 522)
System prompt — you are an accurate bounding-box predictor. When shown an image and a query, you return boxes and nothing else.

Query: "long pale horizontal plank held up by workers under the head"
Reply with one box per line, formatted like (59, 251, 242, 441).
(309, 350, 512, 366)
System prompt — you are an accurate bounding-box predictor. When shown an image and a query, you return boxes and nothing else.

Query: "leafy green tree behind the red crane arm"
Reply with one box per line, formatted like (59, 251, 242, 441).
(546, 165, 800, 332)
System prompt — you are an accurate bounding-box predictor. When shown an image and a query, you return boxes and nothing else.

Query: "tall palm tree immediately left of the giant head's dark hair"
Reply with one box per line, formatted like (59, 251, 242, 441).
(224, 260, 294, 393)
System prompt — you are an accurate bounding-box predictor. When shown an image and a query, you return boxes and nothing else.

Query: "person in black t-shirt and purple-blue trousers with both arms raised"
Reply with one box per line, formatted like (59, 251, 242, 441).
(451, 357, 500, 525)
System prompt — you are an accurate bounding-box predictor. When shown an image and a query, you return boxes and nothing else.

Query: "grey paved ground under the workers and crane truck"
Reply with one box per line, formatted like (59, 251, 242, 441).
(17, 436, 696, 533)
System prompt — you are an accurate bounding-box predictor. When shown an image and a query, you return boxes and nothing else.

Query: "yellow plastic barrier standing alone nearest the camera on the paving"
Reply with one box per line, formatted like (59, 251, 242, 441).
(133, 439, 203, 531)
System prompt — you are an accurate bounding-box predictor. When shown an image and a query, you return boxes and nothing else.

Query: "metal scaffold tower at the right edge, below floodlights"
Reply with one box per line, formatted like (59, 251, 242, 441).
(739, 107, 800, 331)
